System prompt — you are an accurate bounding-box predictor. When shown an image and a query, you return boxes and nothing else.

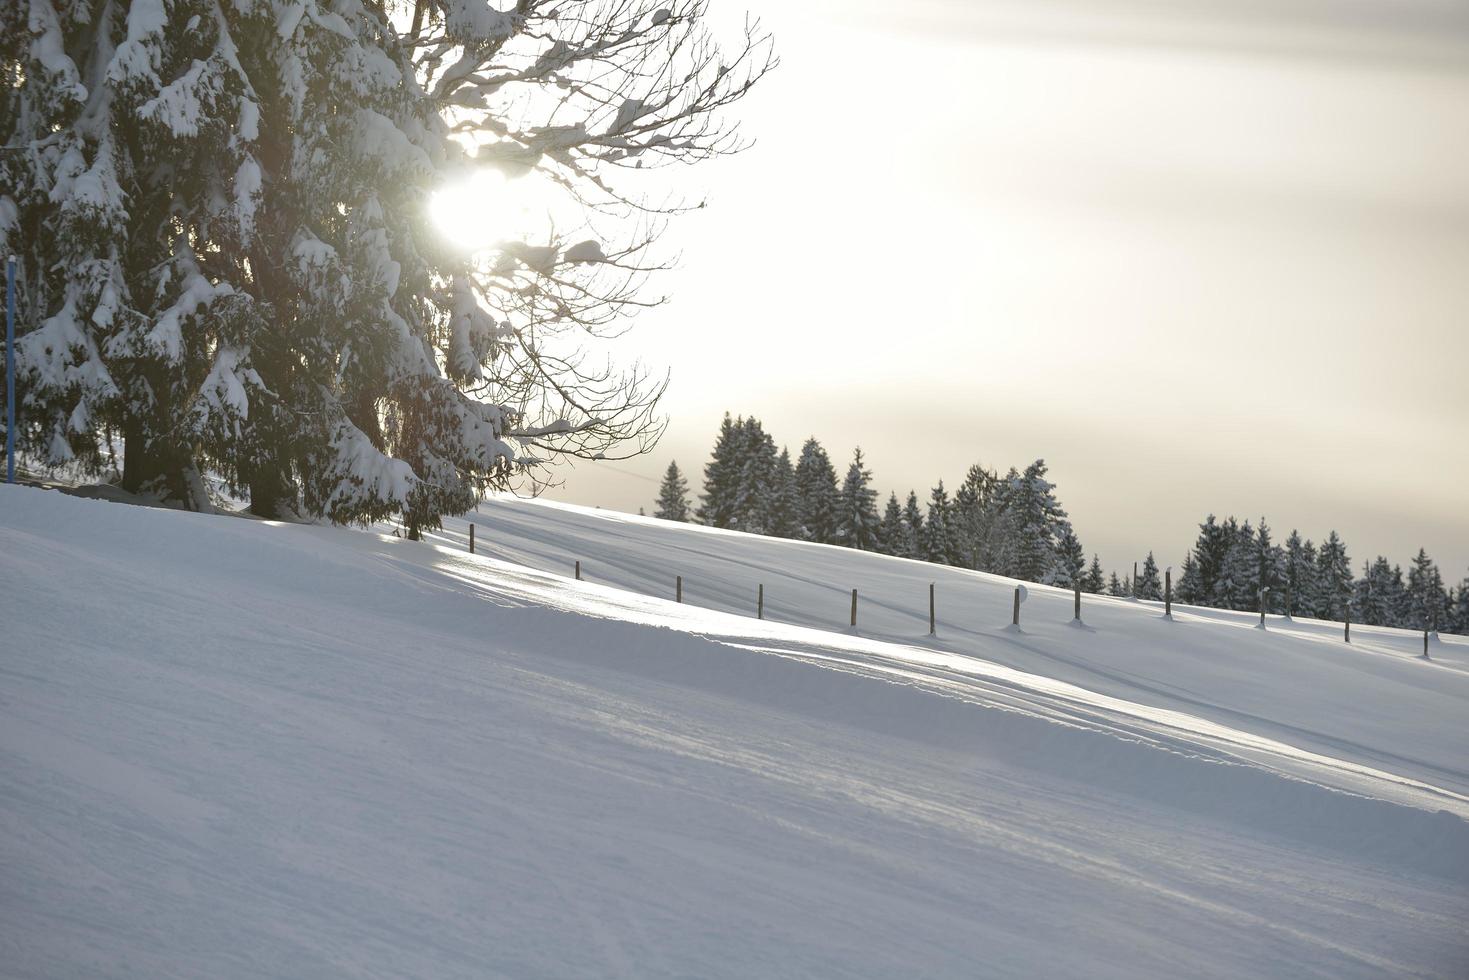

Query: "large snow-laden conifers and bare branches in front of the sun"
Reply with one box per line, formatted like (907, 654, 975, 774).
(0, 0, 771, 536)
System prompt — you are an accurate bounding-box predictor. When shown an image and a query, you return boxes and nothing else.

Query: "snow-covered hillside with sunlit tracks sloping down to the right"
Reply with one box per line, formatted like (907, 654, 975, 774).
(0, 486, 1469, 977)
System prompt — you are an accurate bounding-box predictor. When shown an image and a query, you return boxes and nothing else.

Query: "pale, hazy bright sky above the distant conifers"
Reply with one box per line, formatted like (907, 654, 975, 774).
(537, 0, 1469, 580)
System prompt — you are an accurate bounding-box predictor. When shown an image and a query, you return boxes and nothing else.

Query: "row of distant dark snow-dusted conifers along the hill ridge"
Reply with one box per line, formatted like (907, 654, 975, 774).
(654, 413, 1469, 633)
